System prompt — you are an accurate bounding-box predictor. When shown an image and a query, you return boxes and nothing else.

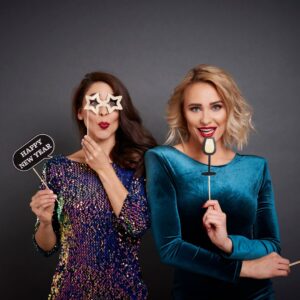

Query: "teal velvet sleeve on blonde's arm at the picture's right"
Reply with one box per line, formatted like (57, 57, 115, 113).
(228, 160, 280, 260)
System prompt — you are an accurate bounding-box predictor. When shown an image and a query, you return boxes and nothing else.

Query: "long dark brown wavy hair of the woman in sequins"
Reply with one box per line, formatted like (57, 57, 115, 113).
(72, 72, 157, 176)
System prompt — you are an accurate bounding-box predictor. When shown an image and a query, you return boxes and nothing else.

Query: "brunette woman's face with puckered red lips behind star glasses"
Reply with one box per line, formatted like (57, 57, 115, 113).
(77, 81, 119, 141)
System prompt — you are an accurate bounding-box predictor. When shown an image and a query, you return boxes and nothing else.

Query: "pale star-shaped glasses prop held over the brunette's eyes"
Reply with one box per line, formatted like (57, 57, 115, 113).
(84, 93, 123, 115)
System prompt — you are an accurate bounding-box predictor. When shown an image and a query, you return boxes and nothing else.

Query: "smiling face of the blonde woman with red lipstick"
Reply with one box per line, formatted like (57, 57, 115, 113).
(183, 82, 227, 145)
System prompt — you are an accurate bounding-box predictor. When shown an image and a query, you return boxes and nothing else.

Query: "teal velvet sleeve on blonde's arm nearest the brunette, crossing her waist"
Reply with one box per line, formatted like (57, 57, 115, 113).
(145, 150, 241, 282)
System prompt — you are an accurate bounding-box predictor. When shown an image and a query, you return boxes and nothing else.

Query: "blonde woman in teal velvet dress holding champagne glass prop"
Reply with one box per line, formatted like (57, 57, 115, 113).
(146, 65, 290, 300)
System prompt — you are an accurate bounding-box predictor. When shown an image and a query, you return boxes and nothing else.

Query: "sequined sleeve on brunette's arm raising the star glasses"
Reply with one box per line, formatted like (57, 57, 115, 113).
(117, 177, 150, 237)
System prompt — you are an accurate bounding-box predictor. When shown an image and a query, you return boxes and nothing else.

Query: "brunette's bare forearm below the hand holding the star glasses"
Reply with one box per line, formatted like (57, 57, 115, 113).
(97, 165, 128, 217)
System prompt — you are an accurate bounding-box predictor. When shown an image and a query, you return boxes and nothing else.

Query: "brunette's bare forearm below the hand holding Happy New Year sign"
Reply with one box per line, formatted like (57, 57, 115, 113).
(34, 223, 56, 251)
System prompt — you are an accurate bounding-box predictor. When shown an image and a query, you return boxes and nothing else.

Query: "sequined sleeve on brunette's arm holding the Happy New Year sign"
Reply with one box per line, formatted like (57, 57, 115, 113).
(32, 161, 61, 257)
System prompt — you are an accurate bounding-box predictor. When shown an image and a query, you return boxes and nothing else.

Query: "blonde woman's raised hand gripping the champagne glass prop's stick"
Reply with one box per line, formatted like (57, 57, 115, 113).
(202, 200, 232, 254)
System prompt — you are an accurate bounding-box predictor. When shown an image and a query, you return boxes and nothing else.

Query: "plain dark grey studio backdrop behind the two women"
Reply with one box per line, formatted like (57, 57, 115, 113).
(0, 0, 300, 300)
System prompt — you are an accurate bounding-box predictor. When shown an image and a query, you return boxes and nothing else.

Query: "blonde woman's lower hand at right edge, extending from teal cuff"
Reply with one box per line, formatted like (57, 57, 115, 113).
(240, 252, 290, 279)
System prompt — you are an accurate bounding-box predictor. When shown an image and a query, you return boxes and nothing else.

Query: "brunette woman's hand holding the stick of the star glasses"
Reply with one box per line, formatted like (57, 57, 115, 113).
(81, 135, 110, 173)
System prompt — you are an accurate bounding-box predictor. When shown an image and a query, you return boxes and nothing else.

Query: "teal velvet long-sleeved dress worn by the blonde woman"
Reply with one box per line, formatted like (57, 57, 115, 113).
(145, 146, 280, 300)
